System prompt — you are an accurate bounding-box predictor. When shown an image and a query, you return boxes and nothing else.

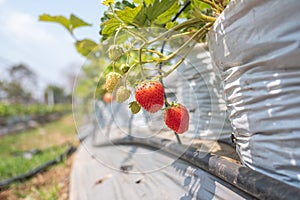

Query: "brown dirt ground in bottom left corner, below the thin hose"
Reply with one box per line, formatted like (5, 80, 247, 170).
(0, 154, 74, 200)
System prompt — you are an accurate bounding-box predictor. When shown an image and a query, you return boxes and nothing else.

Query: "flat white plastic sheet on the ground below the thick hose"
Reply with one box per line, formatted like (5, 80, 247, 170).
(70, 135, 253, 200)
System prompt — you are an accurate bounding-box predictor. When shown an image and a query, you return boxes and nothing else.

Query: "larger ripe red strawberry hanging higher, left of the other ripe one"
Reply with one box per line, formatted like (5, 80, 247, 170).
(135, 81, 164, 113)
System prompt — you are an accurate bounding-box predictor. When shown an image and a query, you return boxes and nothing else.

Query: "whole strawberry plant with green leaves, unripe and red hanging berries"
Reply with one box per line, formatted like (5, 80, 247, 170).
(40, 0, 229, 136)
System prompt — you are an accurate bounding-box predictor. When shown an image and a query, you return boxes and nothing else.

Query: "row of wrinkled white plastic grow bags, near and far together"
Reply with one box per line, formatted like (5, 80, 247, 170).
(170, 0, 300, 189)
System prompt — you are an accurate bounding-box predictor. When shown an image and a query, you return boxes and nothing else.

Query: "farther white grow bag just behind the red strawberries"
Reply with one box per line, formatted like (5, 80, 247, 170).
(164, 44, 232, 143)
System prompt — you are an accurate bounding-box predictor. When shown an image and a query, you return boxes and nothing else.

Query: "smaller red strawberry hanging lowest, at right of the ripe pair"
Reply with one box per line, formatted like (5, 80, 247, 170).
(165, 104, 190, 134)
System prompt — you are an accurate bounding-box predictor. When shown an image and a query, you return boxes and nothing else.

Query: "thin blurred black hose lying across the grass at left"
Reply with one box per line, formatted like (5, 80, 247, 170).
(0, 146, 76, 190)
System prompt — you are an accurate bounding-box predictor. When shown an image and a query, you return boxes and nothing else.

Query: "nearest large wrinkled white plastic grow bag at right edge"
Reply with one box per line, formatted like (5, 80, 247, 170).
(209, 0, 300, 188)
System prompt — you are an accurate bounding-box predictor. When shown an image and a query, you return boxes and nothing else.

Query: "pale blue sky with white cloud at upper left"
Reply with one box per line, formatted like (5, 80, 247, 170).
(0, 0, 106, 95)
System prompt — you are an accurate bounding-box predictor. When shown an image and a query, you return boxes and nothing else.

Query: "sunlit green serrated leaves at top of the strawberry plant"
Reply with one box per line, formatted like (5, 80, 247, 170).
(100, 0, 180, 40)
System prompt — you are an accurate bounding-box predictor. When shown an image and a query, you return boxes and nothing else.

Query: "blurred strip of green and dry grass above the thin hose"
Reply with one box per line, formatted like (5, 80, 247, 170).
(0, 115, 76, 180)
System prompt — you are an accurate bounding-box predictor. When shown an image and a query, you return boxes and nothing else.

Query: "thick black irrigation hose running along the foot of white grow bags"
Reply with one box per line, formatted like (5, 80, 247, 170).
(97, 137, 300, 200)
